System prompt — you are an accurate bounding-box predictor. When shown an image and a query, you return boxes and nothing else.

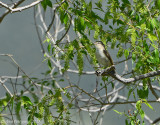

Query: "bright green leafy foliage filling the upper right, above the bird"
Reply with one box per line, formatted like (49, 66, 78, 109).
(40, 0, 160, 124)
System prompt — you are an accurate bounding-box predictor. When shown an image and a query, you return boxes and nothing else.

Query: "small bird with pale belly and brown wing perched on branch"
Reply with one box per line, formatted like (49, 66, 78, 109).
(94, 41, 115, 73)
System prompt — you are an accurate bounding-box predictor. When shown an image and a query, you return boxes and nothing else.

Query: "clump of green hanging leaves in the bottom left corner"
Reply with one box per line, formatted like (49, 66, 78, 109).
(0, 78, 72, 125)
